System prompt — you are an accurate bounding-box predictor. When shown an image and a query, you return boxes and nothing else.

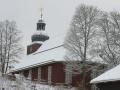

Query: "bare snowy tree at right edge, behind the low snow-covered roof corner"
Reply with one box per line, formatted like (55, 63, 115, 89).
(98, 12, 120, 68)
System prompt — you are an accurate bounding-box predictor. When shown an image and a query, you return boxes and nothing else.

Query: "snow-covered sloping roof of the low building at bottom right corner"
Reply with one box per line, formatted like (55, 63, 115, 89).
(90, 65, 120, 83)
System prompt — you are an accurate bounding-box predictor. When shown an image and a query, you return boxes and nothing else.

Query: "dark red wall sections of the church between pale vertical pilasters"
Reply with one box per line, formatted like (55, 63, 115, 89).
(13, 62, 91, 90)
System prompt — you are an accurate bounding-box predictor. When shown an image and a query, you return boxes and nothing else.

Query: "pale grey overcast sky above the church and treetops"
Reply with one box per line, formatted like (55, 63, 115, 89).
(0, 0, 120, 53)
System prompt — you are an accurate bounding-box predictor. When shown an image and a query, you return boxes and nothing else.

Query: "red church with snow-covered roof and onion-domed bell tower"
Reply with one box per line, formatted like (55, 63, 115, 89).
(12, 12, 104, 90)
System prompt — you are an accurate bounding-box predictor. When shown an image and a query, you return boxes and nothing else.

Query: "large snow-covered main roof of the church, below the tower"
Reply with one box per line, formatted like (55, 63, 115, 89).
(13, 37, 65, 71)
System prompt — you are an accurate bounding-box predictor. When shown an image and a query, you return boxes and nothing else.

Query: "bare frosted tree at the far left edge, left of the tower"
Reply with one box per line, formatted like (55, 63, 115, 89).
(0, 20, 22, 73)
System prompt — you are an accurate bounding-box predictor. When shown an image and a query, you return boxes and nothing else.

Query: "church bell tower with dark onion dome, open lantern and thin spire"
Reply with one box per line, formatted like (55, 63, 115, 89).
(27, 9, 49, 55)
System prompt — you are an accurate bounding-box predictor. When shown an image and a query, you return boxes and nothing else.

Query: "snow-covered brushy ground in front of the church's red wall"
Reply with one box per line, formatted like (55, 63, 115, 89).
(0, 76, 77, 90)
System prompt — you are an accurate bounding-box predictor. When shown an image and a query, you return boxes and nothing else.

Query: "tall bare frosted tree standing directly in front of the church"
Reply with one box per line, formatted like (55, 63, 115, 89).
(64, 5, 101, 90)
